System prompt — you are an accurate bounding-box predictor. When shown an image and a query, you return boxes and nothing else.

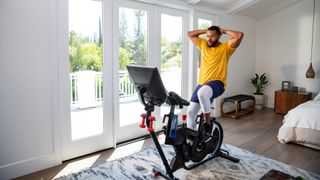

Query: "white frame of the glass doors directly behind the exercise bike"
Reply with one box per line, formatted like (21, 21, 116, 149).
(113, 0, 189, 142)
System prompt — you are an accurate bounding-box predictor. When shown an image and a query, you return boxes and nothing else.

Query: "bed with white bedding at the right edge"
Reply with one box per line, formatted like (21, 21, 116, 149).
(278, 93, 320, 150)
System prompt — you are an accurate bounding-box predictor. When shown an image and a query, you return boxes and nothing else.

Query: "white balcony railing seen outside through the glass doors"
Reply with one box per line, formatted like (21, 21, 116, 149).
(70, 68, 181, 109)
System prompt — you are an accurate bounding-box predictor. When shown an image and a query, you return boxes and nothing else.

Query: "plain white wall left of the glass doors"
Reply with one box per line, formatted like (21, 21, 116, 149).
(0, 0, 56, 179)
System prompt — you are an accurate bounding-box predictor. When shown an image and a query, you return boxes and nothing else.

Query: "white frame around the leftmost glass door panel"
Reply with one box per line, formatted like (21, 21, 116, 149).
(54, 0, 115, 161)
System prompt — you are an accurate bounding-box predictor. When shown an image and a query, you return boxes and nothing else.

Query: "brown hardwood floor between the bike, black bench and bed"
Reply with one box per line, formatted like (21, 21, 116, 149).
(218, 109, 320, 174)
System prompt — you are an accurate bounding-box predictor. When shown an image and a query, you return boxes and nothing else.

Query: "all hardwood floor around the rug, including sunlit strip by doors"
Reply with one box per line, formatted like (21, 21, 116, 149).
(17, 108, 320, 179)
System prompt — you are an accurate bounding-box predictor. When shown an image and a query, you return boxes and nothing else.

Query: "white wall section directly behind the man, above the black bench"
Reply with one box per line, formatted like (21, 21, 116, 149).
(215, 14, 256, 116)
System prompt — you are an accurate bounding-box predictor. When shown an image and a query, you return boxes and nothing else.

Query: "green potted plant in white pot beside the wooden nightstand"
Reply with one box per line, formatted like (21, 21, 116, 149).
(251, 73, 269, 109)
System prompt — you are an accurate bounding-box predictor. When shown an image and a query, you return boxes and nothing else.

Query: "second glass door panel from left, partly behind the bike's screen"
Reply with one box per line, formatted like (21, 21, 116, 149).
(117, 3, 148, 142)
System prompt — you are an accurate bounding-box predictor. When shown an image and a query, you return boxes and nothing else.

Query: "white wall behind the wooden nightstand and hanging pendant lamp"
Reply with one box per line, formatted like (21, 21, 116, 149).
(255, 1, 320, 107)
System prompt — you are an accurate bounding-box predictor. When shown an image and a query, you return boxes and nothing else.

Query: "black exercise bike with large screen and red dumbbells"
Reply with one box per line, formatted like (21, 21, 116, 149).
(127, 66, 239, 179)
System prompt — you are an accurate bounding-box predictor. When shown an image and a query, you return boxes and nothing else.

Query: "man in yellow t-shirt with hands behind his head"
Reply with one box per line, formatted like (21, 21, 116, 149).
(187, 26, 243, 134)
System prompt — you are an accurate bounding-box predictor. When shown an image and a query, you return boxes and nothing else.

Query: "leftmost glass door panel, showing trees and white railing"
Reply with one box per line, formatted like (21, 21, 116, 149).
(69, 0, 103, 141)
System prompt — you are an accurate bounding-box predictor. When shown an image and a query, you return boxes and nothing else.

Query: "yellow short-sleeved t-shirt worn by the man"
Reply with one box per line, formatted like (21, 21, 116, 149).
(197, 38, 236, 87)
